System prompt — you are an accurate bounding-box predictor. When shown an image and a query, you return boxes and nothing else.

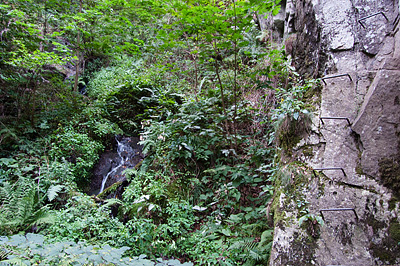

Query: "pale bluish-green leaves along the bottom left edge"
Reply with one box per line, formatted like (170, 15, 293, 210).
(0, 233, 193, 266)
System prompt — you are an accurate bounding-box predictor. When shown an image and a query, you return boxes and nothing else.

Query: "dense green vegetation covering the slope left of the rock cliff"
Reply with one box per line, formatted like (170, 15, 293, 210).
(0, 0, 314, 265)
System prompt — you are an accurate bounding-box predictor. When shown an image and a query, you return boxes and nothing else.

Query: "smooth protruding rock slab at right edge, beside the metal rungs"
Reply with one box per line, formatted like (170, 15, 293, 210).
(352, 68, 400, 184)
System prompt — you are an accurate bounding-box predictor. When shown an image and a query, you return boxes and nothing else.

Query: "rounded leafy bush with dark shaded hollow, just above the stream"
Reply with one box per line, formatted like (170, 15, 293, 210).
(88, 57, 181, 133)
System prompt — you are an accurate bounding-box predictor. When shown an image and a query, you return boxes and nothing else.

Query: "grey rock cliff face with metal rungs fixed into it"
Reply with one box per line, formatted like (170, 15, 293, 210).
(270, 0, 400, 265)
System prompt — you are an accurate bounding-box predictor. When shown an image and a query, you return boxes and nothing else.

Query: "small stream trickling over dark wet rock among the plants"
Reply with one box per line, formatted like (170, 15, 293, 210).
(90, 136, 143, 195)
